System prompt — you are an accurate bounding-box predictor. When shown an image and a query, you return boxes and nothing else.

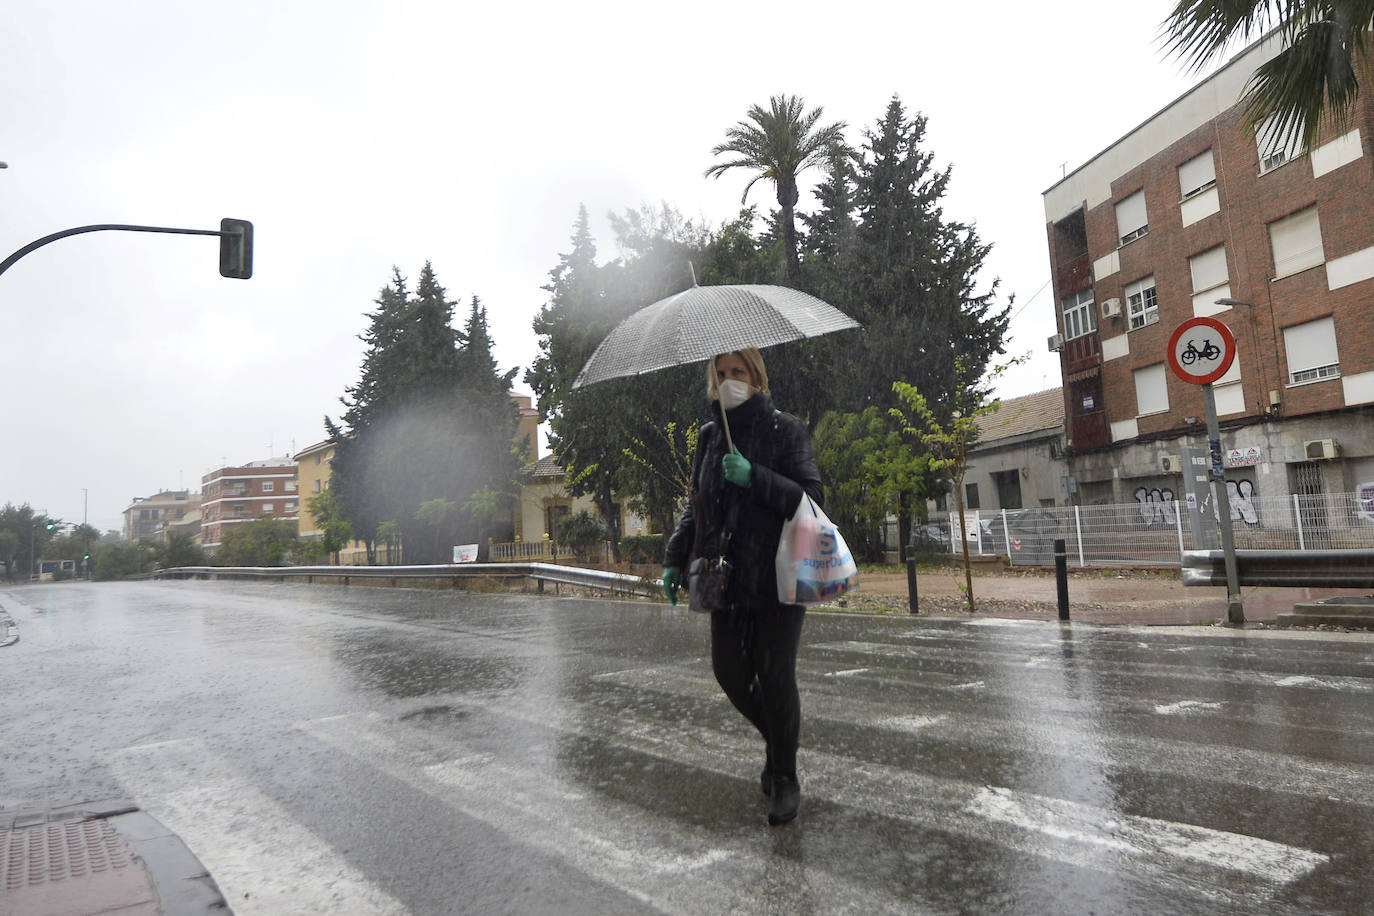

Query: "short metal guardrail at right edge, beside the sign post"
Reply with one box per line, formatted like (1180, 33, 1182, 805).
(1182, 549, 1374, 588)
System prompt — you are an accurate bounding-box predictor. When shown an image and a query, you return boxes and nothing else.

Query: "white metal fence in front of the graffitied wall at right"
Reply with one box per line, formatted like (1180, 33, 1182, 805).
(923, 488, 1374, 566)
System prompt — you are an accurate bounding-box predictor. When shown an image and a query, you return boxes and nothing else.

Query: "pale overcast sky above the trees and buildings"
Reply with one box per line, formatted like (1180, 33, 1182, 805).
(0, 0, 1225, 530)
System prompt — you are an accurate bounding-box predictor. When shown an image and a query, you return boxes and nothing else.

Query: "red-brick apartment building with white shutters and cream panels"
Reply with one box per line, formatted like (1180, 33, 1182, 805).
(1044, 36, 1374, 516)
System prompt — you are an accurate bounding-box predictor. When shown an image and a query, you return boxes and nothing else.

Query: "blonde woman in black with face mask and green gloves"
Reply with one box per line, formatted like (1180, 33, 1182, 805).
(664, 347, 822, 824)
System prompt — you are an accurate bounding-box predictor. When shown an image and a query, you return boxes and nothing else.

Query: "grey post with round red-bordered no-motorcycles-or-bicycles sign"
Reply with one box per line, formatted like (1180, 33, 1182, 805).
(1168, 317, 1245, 625)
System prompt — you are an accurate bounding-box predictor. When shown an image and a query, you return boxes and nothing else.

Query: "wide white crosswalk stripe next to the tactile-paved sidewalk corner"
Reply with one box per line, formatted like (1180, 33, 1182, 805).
(111, 739, 408, 916)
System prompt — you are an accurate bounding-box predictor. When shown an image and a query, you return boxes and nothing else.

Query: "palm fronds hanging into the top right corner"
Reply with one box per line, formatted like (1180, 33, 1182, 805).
(1162, 0, 1374, 150)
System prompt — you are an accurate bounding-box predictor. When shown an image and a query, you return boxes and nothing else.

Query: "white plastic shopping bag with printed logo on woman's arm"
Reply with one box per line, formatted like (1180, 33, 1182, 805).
(776, 494, 859, 604)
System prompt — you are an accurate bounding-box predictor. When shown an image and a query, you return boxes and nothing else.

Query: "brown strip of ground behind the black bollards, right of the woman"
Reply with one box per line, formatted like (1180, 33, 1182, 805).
(849, 567, 1370, 626)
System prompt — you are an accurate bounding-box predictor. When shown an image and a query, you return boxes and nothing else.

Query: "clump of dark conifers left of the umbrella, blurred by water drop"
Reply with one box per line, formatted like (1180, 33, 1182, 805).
(326, 264, 519, 563)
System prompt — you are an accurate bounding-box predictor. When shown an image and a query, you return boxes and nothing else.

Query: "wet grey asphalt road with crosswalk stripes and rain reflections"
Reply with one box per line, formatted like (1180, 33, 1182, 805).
(0, 582, 1374, 916)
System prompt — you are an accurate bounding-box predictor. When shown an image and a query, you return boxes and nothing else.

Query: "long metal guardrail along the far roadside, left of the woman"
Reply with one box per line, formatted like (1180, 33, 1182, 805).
(153, 563, 660, 596)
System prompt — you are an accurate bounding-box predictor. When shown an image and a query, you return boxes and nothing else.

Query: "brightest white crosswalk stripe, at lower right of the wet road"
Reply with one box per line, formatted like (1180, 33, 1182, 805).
(967, 787, 1330, 884)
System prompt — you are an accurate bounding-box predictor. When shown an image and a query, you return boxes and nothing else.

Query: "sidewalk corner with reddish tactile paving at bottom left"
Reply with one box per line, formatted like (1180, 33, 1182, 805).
(0, 801, 229, 916)
